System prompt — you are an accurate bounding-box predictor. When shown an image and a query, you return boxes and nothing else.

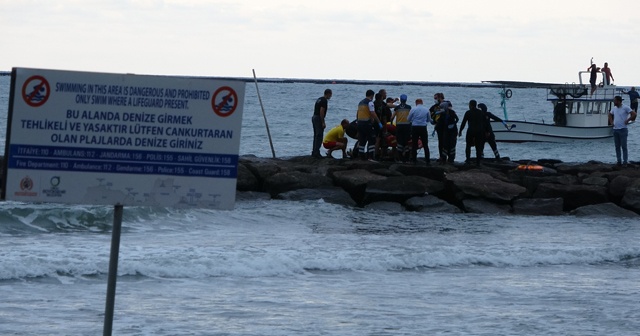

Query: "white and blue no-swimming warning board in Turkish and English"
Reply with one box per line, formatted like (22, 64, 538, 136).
(0, 68, 245, 209)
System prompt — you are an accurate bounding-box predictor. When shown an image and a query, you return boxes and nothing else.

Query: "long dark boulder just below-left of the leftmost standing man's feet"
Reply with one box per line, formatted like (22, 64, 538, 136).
(264, 171, 333, 196)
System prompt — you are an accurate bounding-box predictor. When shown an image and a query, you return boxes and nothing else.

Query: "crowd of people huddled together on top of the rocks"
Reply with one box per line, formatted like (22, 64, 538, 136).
(311, 89, 506, 165)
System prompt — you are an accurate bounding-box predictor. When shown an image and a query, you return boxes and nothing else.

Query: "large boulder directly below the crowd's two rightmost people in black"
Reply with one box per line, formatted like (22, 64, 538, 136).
(446, 170, 527, 203)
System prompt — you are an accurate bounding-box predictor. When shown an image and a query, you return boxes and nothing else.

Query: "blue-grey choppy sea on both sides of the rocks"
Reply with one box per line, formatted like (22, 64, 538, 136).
(0, 72, 640, 336)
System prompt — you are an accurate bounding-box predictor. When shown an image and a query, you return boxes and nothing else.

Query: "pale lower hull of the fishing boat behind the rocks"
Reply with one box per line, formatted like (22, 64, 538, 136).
(491, 121, 613, 142)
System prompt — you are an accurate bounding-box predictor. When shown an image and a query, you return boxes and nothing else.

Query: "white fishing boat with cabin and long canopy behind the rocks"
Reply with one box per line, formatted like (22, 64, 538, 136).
(491, 71, 619, 142)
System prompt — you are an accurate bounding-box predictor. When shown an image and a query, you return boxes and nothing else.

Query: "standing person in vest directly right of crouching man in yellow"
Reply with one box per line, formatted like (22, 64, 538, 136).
(356, 90, 382, 161)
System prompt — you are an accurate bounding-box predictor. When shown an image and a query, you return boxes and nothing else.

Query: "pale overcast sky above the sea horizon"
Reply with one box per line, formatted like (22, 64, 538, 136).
(0, 0, 640, 86)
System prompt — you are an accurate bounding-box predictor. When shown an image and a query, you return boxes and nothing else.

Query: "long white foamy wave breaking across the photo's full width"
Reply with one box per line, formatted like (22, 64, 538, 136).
(0, 241, 640, 281)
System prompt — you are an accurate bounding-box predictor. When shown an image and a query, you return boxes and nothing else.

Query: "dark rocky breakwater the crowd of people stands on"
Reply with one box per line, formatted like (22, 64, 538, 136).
(237, 156, 640, 217)
